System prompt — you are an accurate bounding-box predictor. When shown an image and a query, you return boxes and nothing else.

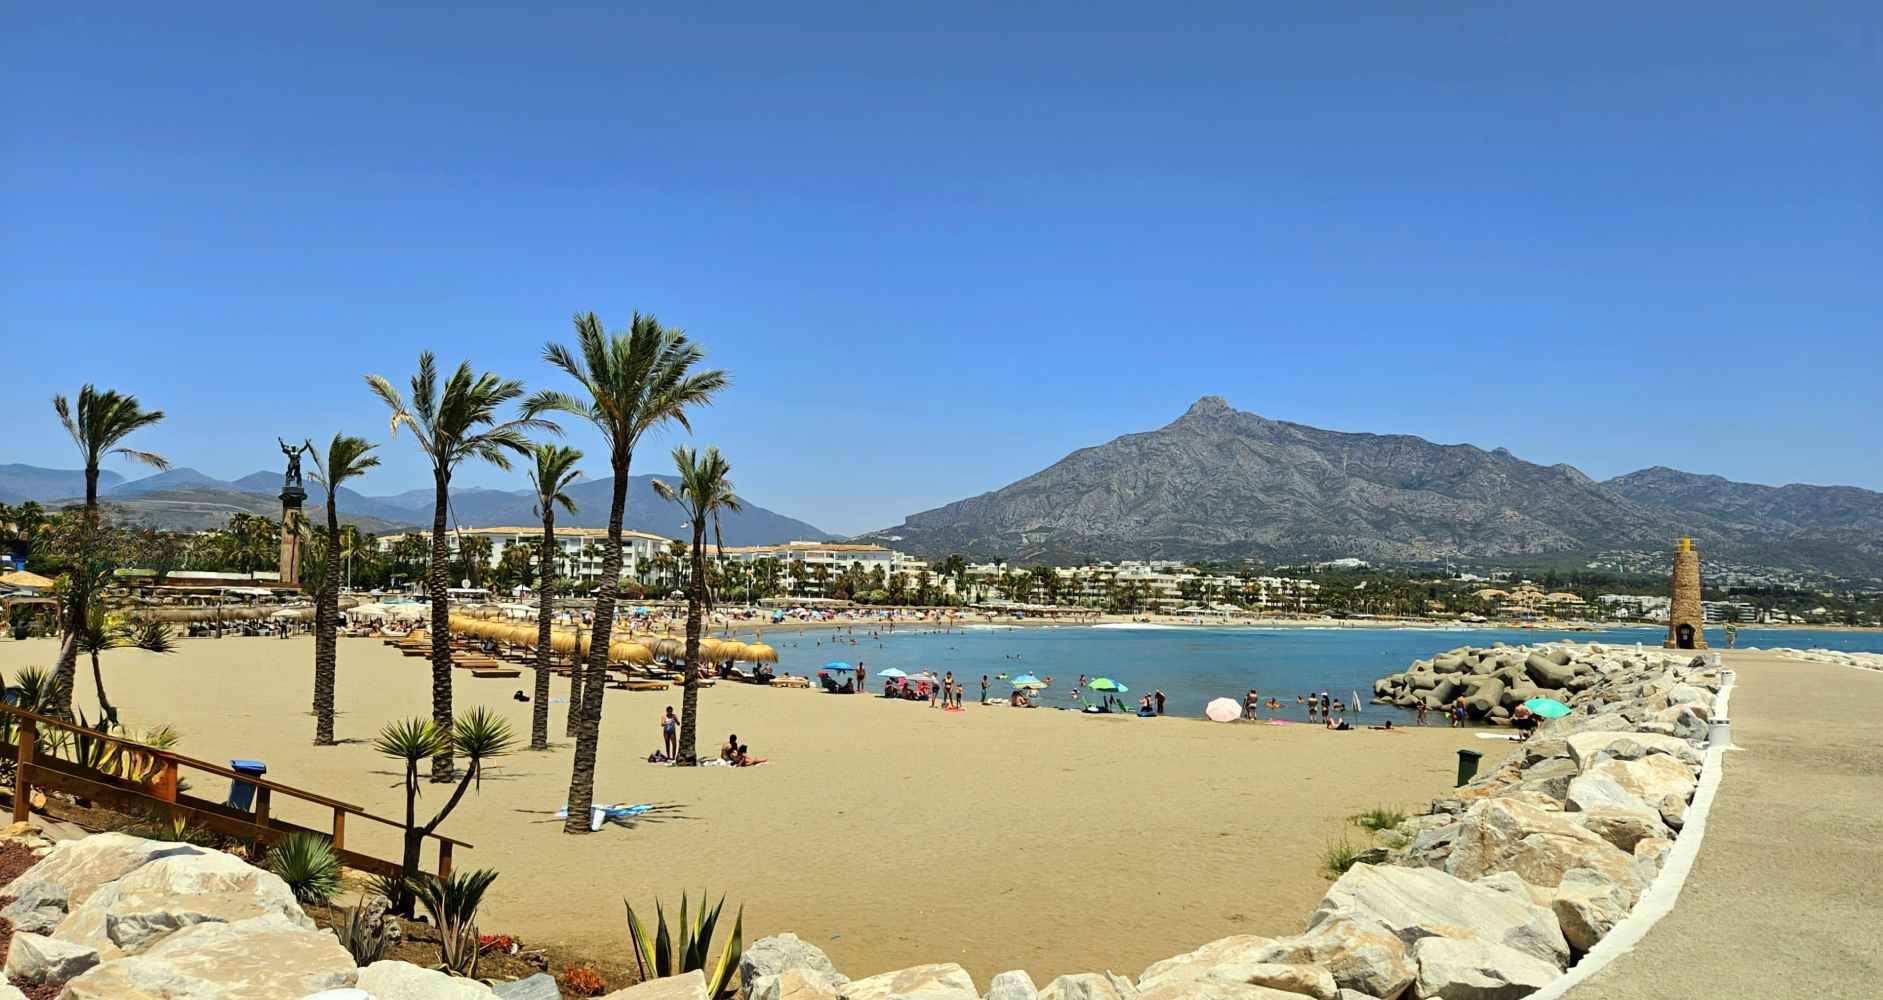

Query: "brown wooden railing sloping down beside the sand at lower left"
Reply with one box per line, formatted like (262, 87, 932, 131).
(0, 704, 471, 878)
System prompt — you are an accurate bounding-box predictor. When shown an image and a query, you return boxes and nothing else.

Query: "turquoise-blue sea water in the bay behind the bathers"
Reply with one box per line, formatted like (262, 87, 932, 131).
(764, 625, 1883, 721)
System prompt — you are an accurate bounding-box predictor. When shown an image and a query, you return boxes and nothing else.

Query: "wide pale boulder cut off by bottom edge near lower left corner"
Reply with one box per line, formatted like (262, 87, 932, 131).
(60, 921, 359, 1000)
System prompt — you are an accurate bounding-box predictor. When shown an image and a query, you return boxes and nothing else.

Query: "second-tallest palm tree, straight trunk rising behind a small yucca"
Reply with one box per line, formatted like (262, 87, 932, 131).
(365, 350, 549, 783)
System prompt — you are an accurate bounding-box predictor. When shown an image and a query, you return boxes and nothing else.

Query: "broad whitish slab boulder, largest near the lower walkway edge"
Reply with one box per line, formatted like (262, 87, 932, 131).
(1309, 864, 1569, 968)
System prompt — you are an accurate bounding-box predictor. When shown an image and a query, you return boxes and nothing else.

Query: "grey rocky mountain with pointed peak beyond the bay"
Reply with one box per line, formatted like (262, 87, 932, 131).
(864, 395, 1883, 576)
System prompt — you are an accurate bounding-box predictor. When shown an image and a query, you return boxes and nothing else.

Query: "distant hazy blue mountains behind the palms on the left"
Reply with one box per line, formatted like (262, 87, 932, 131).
(0, 465, 834, 544)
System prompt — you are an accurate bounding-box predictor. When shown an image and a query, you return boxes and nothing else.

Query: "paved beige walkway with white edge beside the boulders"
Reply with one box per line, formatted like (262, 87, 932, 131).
(1569, 652, 1883, 1000)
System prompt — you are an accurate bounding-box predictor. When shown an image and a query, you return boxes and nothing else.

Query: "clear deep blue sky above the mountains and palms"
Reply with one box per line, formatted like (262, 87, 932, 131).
(0, 0, 1883, 531)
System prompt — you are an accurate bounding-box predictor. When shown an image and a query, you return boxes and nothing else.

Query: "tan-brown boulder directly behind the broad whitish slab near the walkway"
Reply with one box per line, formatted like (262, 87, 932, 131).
(1444, 798, 1640, 902)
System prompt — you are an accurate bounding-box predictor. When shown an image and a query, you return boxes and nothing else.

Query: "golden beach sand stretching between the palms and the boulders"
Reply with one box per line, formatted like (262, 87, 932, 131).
(0, 637, 1505, 987)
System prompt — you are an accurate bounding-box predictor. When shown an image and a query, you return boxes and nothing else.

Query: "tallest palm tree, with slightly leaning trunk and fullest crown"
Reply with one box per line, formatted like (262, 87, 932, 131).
(525, 313, 727, 832)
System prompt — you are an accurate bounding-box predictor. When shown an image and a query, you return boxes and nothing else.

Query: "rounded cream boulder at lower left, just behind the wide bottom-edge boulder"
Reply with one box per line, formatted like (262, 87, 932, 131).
(53, 851, 314, 960)
